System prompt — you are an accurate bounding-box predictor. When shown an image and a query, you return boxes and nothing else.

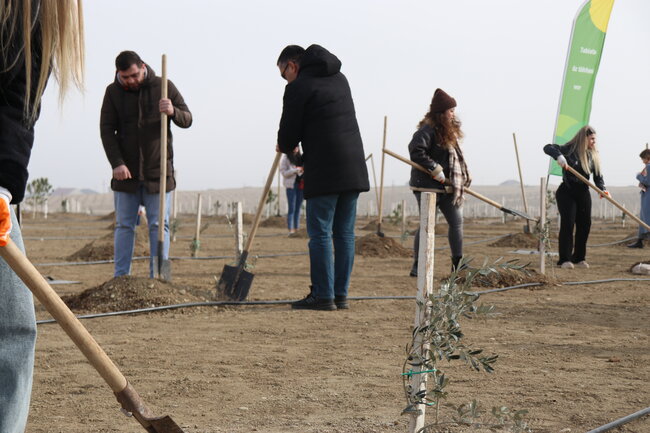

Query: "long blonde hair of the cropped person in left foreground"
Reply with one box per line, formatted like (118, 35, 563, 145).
(0, 0, 84, 123)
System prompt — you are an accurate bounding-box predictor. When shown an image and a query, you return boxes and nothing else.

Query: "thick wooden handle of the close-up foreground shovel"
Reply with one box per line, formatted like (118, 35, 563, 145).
(0, 240, 127, 392)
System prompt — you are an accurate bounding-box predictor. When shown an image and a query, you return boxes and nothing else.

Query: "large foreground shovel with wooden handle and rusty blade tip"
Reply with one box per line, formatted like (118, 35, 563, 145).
(0, 240, 183, 433)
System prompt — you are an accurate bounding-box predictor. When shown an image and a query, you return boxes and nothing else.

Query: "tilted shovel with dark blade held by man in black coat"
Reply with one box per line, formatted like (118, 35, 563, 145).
(217, 152, 282, 301)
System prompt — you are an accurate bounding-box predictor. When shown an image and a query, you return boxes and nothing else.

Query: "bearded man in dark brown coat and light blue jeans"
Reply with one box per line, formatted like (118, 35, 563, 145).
(100, 51, 192, 278)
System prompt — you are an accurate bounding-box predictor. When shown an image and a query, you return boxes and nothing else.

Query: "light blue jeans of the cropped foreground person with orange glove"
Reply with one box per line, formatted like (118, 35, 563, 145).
(0, 206, 36, 433)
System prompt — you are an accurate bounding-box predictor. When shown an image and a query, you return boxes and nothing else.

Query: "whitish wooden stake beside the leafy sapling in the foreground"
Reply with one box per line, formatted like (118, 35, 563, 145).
(409, 192, 436, 433)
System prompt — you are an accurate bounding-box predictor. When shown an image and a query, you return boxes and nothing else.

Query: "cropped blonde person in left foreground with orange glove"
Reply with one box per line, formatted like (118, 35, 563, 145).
(0, 0, 84, 433)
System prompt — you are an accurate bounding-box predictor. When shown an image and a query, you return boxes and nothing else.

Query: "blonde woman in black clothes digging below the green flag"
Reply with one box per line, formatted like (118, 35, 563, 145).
(544, 125, 609, 269)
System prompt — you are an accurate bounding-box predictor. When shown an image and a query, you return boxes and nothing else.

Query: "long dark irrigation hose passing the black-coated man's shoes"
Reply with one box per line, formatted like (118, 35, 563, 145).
(36, 278, 650, 325)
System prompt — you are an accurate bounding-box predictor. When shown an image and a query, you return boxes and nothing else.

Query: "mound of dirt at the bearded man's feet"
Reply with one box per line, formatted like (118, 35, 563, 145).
(62, 275, 208, 313)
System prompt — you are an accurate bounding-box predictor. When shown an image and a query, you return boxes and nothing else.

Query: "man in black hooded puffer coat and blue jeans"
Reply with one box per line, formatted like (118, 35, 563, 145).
(277, 45, 370, 310)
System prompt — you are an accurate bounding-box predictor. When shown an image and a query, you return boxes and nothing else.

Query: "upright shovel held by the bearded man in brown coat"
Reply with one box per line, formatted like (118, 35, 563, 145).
(154, 54, 172, 281)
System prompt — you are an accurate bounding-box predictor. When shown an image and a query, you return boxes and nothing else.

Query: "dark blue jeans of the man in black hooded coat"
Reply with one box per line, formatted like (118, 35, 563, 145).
(307, 192, 359, 299)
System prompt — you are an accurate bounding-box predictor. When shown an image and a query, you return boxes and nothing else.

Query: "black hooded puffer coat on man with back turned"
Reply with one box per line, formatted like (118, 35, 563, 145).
(278, 45, 370, 199)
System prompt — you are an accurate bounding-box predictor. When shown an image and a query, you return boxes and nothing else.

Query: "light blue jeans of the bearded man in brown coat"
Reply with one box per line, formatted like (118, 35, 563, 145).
(114, 185, 171, 278)
